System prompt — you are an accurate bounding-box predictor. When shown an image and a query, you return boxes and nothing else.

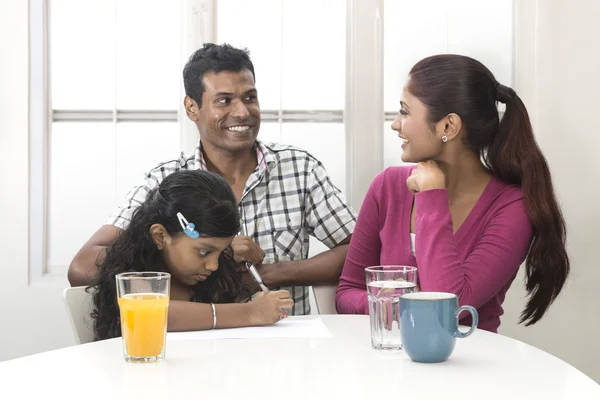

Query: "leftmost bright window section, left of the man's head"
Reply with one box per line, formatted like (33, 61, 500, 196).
(32, 0, 181, 273)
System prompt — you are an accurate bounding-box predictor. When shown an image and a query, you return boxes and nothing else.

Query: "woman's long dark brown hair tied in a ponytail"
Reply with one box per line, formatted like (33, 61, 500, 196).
(408, 54, 570, 325)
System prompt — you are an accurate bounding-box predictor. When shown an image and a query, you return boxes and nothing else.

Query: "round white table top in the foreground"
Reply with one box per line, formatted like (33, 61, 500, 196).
(0, 315, 600, 400)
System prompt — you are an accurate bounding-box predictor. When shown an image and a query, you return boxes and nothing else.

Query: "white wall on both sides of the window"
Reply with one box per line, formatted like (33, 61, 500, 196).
(0, 0, 600, 382)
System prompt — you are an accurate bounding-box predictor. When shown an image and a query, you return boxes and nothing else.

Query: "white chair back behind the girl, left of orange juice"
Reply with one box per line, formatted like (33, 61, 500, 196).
(63, 286, 94, 344)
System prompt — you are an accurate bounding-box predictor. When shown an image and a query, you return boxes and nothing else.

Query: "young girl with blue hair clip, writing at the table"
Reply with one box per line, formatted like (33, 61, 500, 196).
(92, 171, 293, 340)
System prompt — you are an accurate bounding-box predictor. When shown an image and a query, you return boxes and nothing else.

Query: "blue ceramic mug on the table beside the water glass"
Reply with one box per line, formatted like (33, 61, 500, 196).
(400, 292, 479, 363)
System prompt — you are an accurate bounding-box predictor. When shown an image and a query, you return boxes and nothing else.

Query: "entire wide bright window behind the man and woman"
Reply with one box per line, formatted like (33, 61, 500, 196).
(30, 0, 513, 278)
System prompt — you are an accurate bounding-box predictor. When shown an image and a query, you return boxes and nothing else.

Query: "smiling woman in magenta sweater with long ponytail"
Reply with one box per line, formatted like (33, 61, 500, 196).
(336, 55, 570, 332)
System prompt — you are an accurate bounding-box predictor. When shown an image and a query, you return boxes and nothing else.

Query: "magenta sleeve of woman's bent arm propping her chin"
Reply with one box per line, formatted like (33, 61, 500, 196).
(415, 189, 532, 308)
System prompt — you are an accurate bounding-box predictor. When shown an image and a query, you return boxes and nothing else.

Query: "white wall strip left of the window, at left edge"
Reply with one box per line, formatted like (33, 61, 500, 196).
(0, 0, 74, 361)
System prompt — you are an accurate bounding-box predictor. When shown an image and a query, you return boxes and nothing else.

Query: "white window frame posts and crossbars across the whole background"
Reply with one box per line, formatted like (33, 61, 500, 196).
(29, 0, 524, 283)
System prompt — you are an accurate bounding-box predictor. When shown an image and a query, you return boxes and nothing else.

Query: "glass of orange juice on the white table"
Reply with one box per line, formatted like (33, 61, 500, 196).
(116, 272, 171, 363)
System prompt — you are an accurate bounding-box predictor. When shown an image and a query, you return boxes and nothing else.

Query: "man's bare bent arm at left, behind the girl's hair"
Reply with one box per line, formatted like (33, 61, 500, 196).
(67, 225, 122, 286)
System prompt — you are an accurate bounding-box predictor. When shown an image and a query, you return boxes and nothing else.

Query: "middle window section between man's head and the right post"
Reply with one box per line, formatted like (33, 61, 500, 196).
(216, 0, 346, 253)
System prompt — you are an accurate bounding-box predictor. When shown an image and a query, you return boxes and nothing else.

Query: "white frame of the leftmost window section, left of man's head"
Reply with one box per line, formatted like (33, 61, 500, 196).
(29, 0, 193, 284)
